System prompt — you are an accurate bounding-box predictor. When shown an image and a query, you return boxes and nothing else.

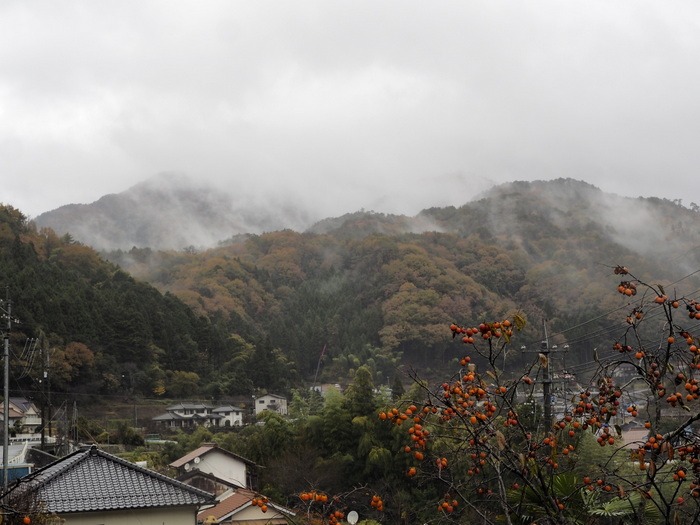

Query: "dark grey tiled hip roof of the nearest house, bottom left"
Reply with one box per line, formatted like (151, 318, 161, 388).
(8, 446, 213, 513)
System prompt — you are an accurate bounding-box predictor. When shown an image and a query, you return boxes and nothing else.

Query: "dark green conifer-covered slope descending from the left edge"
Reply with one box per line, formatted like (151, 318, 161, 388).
(0, 206, 278, 397)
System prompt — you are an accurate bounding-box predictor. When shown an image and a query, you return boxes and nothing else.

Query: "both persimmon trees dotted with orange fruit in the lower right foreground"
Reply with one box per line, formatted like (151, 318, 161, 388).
(379, 266, 700, 524)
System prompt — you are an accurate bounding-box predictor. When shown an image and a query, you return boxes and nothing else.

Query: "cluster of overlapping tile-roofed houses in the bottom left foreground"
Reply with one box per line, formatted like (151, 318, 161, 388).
(4, 444, 294, 525)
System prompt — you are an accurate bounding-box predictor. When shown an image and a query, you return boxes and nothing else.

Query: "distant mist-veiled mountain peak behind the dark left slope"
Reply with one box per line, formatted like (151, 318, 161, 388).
(34, 173, 317, 250)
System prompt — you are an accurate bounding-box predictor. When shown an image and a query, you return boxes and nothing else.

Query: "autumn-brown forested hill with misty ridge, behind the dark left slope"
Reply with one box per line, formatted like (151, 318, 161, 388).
(109, 179, 700, 390)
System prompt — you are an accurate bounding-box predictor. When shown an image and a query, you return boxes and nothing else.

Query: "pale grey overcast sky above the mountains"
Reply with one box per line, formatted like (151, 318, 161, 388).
(0, 0, 700, 216)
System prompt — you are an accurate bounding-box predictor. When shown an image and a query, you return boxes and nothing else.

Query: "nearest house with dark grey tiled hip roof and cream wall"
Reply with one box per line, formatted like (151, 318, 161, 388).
(3, 445, 214, 525)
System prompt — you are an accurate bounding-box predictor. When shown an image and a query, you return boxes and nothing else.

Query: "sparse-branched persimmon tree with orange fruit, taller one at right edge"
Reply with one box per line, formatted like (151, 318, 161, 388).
(575, 266, 700, 523)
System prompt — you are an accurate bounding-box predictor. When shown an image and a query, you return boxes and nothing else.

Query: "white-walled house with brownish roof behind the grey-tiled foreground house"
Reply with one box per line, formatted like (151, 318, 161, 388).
(170, 443, 257, 489)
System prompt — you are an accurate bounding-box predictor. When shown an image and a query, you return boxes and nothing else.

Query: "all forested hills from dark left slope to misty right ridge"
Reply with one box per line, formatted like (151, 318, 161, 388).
(0, 179, 700, 408)
